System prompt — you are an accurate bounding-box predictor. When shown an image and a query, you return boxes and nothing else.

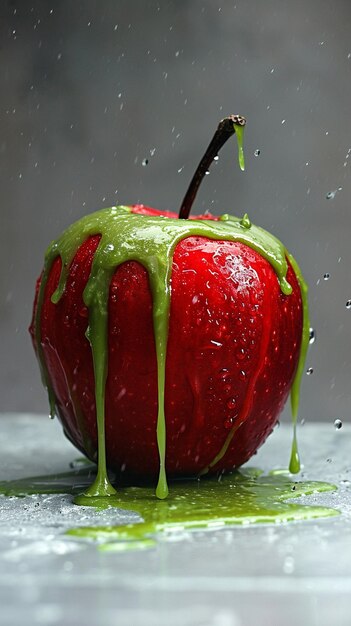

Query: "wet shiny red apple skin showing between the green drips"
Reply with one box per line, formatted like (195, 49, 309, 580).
(30, 205, 303, 479)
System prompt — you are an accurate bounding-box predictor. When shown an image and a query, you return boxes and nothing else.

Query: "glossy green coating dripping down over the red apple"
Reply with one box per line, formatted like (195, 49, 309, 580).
(35, 206, 309, 505)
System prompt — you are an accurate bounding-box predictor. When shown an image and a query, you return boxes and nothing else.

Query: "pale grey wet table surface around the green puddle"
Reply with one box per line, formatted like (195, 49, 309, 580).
(0, 414, 351, 626)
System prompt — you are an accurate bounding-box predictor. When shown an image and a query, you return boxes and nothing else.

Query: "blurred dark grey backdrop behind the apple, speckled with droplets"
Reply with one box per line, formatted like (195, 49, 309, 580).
(0, 0, 351, 428)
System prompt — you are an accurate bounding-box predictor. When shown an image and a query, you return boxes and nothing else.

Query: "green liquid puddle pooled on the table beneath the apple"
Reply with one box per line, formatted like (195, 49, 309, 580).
(0, 463, 339, 551)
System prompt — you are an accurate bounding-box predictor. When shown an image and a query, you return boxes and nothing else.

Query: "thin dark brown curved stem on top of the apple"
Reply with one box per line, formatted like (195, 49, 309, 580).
(178, 115, 246, 220)
